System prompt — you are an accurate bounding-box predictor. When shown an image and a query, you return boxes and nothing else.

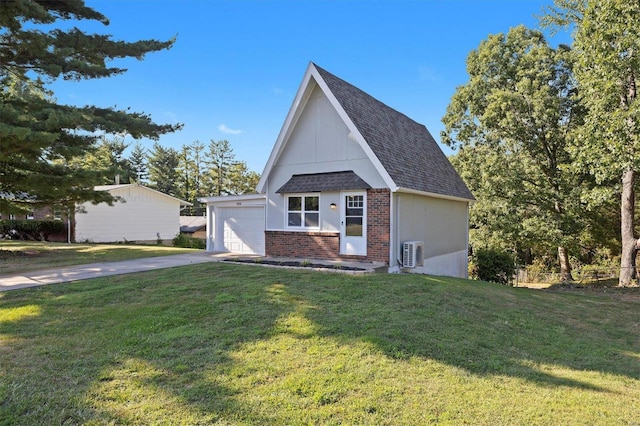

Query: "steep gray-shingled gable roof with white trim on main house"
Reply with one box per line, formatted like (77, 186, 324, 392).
(258, 63, 474, 200)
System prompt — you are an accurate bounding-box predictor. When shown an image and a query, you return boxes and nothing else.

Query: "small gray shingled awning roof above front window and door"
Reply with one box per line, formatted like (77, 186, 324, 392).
(276, 170, 371, 194)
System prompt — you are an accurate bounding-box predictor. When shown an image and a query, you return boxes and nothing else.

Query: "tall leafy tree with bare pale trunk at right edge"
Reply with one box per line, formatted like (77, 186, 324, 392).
(574, 0, 640, 286)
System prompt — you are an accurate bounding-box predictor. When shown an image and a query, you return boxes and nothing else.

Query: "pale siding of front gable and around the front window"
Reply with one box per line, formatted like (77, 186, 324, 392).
(266, 87, 386, 232)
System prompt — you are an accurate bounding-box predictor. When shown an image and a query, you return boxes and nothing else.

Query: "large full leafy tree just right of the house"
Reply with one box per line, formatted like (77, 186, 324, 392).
(442, 26, 581, 280)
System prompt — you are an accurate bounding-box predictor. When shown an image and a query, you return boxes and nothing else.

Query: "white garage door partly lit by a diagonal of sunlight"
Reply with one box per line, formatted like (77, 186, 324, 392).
(217, 206, 265, 256)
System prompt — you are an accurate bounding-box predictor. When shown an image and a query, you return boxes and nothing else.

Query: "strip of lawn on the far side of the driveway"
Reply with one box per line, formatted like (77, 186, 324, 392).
(0, 241, 201, 275)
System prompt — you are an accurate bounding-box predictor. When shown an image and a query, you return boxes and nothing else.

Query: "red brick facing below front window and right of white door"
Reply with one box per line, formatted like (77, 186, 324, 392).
(265, 189, 390, 263)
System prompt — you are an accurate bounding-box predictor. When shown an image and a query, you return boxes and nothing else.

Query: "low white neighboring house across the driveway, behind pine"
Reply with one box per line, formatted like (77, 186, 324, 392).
(75, 184, 191, 243)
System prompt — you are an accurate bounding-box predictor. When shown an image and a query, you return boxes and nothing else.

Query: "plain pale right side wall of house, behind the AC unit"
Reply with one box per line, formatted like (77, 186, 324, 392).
(395, 193, 468, 278)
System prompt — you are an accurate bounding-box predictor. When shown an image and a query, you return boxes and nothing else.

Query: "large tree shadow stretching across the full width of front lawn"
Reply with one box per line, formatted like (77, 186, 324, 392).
(0, 264, 640, 424)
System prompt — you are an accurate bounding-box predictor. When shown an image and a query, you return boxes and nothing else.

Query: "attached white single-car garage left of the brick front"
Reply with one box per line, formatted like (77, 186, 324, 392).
(200, 194, 266, 256)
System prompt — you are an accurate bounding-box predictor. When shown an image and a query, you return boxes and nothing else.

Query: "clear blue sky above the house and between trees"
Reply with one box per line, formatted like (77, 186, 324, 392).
(51, 0, 568, 172)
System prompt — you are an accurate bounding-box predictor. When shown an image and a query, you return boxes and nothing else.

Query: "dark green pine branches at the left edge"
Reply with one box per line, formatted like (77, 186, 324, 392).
(0, 0, 180, 210)
